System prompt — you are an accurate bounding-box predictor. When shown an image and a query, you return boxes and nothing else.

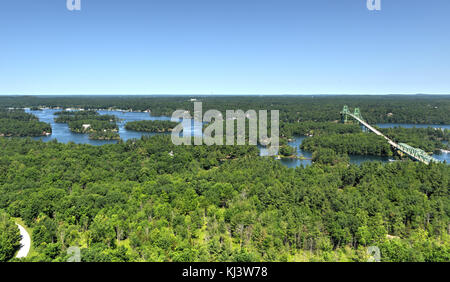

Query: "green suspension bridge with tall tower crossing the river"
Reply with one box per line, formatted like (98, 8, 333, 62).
(341, 105, 439, 164)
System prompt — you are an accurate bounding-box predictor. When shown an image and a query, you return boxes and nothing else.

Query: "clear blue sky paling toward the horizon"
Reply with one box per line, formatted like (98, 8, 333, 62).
(0, 0, 450, 94)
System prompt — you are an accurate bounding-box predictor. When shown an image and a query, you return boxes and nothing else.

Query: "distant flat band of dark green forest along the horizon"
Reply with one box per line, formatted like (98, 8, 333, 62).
(0, 95, 450, 124)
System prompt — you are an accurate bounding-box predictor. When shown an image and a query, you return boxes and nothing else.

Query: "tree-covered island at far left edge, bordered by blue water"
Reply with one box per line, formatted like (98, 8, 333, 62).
(0, 108, 52, 137)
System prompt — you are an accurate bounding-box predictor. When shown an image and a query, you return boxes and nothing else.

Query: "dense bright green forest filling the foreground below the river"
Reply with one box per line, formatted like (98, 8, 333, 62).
(0, 135, 450, 262)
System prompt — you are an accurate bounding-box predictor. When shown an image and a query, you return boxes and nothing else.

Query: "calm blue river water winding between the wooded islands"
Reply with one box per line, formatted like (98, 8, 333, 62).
(26, 109, 450, 167)
